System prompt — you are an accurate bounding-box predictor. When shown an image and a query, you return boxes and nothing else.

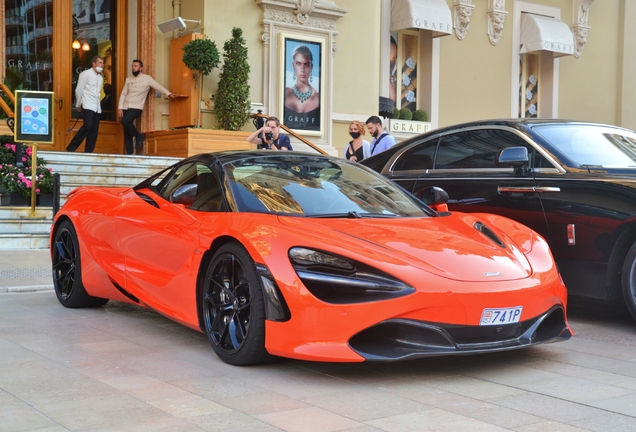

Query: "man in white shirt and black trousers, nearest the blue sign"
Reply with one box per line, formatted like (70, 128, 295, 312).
(66, 56, 104, 153)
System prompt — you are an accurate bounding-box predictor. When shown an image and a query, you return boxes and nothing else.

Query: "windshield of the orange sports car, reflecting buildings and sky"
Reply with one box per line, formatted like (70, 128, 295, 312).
(223, 155, 428, 217)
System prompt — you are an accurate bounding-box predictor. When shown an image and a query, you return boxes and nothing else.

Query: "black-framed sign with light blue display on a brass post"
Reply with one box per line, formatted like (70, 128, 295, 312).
(14, 90, 54, 143)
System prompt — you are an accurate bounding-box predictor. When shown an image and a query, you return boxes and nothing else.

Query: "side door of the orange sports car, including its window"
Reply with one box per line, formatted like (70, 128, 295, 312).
(117, 162, 210, 317)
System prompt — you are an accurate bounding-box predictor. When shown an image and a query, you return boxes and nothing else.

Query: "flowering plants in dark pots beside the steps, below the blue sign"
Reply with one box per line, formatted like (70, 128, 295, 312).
(0, 135, 53, 205)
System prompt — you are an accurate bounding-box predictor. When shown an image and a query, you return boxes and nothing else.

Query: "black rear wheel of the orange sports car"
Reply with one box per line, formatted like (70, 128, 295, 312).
(52, 220, 108, 308)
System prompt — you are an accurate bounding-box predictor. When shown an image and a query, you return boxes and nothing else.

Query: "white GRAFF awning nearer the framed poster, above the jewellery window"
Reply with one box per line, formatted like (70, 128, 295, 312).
(390, 0, 453, 37)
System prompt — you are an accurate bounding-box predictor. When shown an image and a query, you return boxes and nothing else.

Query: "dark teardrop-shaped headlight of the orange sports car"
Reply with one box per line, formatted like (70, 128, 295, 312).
(289, 247, 415, 304)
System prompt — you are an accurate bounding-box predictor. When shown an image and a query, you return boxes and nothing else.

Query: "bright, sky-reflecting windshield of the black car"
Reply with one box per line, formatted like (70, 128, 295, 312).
(533, 124, 636, 168)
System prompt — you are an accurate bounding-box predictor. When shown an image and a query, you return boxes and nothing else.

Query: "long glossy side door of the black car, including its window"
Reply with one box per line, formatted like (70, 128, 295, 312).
(400, 126, 549, 241)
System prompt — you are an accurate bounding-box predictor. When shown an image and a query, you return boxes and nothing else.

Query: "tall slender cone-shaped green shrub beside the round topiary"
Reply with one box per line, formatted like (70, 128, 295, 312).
(214, 27, 250, 131)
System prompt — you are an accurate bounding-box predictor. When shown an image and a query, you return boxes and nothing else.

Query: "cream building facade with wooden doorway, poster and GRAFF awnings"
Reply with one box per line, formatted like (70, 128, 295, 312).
(0, 0, 636, 154)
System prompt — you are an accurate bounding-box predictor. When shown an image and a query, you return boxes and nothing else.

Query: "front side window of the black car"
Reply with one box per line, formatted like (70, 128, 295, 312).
(435, 129, 549, 169)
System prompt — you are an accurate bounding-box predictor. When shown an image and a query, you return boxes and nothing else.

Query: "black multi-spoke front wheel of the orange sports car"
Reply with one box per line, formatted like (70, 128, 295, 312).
(201, 243, 272, 366)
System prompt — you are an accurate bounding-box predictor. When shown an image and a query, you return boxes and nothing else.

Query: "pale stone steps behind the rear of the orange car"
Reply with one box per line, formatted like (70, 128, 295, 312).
(0, 151, 180, 249)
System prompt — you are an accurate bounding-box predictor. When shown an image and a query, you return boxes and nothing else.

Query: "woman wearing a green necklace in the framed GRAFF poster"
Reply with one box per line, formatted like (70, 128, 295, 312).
(283, 45, 320, 131)
